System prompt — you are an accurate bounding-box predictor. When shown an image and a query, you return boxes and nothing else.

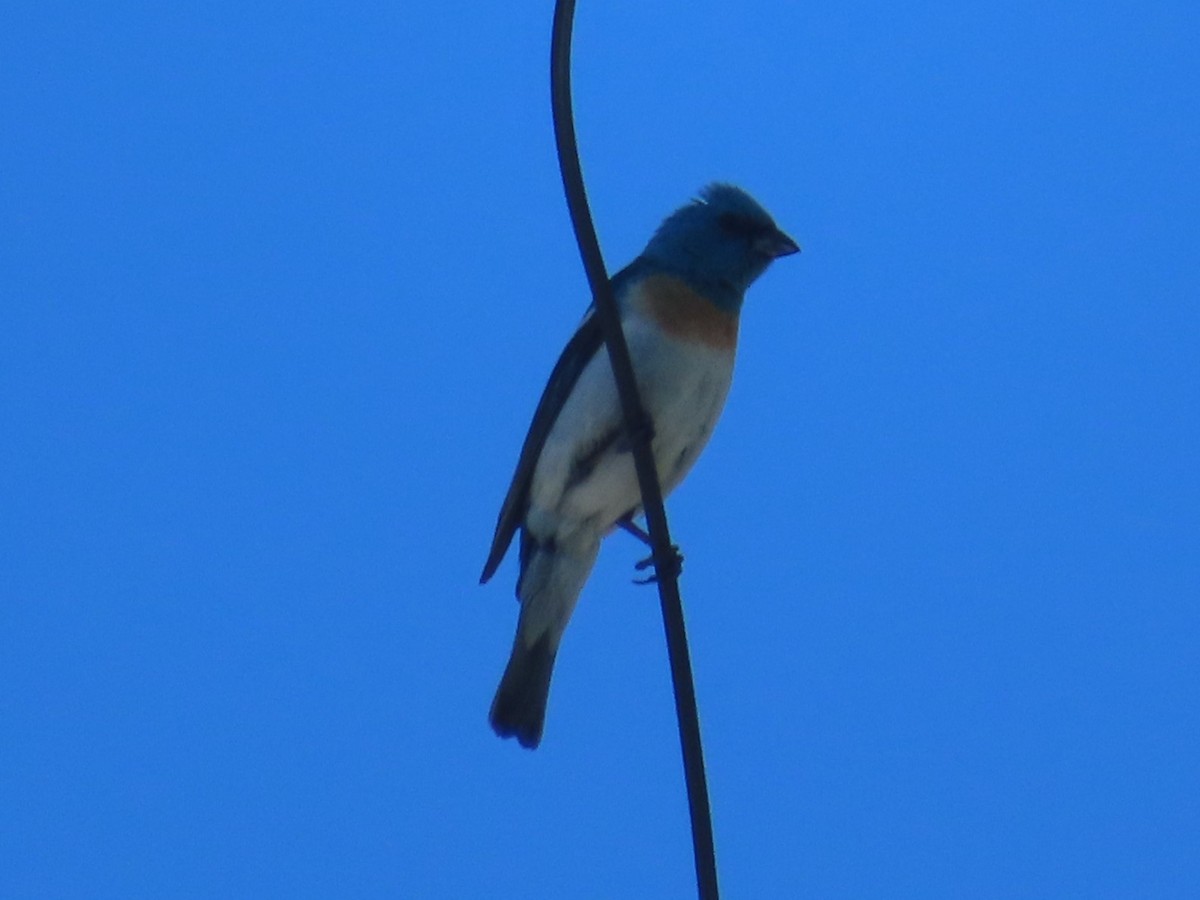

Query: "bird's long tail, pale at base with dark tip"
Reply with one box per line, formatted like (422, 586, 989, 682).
(488, 540, 600, 750)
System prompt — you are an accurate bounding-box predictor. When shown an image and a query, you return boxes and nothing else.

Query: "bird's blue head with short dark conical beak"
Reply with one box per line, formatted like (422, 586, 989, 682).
(642, 184, 800, 312)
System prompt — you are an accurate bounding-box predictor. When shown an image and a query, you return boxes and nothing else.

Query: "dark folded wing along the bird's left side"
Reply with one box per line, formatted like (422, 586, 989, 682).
(479, 262, 641, 584)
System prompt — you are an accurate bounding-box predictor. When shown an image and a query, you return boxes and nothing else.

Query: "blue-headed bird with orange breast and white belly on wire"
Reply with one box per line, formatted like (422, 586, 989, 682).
(480, 182, 800, 749)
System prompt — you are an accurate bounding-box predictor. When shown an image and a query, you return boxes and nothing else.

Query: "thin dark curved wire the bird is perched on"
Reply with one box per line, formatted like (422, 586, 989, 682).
(550, 0, 718, 900)
